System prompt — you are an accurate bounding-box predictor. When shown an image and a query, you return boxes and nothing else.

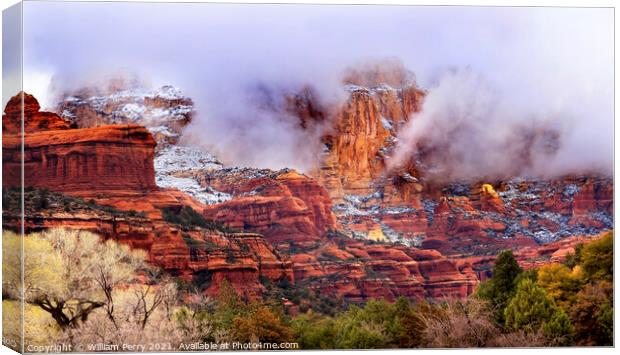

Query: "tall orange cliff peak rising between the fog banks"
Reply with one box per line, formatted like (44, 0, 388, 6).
(315, 68, 425, 201)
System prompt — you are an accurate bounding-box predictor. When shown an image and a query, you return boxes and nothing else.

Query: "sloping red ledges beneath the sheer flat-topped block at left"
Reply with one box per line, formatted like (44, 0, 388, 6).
(3, 190, 294, 298)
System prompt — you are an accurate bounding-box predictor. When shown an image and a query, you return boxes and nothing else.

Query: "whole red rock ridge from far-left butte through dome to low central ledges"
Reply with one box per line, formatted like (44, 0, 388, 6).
(3, 90, 478, 301)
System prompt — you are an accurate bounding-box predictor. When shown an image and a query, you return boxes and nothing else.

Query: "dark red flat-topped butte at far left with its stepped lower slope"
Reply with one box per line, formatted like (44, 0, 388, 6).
(3, 93, 293, 297)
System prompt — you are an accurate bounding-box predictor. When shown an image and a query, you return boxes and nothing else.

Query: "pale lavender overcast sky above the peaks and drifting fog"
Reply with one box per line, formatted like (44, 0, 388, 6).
(5, 2, 613, 177)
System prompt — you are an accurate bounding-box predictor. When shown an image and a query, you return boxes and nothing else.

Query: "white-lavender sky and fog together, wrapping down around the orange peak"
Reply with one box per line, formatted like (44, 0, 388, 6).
(17, 2, 614, 179)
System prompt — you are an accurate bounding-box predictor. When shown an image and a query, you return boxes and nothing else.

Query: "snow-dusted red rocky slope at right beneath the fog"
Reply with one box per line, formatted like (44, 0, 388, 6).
(335, 176, 613, 255)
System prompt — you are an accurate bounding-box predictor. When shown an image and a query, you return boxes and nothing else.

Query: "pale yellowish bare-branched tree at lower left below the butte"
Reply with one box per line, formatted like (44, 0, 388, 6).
(12, 229, 144, 328)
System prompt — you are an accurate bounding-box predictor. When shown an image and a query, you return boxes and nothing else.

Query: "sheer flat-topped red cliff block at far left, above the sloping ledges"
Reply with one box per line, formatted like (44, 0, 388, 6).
(2, 125, 157, 192)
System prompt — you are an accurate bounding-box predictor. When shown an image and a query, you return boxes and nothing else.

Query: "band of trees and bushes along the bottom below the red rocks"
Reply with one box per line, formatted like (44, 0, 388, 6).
(2, 229, 613, 351)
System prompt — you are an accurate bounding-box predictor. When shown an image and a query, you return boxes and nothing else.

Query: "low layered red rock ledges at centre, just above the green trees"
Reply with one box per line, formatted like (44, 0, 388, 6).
(291, 237, 478, 302)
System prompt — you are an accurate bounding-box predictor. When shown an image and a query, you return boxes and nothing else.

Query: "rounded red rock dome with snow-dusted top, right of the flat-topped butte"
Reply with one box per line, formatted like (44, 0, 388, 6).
(203, 169, 336, 245)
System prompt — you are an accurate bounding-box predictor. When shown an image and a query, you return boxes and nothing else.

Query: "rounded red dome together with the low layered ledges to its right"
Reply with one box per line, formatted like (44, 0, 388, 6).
(196, 169, 478, 302)
